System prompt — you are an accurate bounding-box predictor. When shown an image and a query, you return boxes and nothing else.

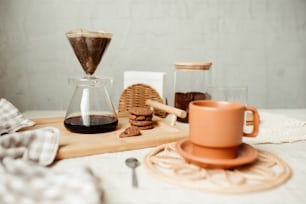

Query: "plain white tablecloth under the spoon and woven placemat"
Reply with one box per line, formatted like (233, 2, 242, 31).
(24, 109, 306, 204)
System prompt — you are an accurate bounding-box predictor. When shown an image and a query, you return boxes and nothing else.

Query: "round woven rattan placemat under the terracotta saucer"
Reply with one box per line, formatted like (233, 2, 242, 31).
(145, 143, 291, 194)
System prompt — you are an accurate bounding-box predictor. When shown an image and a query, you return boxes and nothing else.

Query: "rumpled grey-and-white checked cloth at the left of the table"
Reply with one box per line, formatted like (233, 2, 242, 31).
(0, 99, 103, 204)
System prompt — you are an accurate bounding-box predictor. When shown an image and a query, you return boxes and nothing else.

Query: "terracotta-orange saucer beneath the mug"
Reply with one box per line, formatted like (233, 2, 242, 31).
(175, 139, 258, 169)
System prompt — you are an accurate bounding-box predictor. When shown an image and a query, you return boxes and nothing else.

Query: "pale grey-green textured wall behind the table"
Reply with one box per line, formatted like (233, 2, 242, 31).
(0, 0, 306, 110)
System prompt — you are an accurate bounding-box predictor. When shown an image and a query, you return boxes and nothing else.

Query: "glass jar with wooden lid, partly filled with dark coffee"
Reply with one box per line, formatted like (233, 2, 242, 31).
(174, 62, 212, 123)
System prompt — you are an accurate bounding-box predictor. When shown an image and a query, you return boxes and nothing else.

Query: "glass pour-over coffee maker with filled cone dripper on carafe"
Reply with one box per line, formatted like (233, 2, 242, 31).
(64, 29, 118, 133)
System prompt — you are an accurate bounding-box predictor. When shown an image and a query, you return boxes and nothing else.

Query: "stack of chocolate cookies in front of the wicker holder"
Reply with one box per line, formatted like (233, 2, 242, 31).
(129, 107, 154, 130)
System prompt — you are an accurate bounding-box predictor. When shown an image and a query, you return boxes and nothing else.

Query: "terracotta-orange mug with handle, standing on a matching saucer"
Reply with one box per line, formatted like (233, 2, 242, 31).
(189, 100, 259, 159)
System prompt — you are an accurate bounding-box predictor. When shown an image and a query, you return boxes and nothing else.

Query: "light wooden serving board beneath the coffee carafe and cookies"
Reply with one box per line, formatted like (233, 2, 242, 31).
(28, 116, 188, 160)
